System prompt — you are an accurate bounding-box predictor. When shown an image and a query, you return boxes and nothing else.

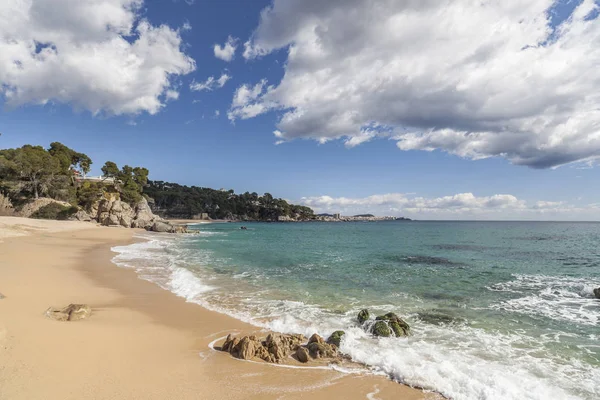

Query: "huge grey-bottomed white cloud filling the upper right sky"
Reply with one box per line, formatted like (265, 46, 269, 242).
(236, 0, 600, 168)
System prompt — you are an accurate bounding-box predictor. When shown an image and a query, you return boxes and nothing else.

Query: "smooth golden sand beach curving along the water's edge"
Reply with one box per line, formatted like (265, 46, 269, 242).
(0, 217, 436, 400)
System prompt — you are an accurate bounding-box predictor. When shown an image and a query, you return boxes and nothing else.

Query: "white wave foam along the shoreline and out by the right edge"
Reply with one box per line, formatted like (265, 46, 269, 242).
(113, 235, 600, 400)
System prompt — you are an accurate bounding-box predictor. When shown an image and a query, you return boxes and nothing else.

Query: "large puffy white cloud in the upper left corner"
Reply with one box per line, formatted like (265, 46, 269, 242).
(0, 0, 195, 115)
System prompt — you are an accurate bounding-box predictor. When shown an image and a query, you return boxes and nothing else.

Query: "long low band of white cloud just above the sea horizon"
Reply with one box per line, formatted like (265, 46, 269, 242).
(300, 193, 600, 220)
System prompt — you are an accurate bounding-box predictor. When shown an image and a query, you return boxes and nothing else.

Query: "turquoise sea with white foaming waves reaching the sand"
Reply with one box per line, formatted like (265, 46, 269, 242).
(113, 221, 600, 400)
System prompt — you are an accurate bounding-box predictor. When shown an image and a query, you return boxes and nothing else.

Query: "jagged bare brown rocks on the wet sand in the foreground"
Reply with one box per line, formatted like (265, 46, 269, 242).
(221, 333, 338, 363)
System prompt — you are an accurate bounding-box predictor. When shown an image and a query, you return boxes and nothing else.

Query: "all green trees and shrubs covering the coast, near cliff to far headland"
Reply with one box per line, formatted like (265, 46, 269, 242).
(0, 142, 314, 221)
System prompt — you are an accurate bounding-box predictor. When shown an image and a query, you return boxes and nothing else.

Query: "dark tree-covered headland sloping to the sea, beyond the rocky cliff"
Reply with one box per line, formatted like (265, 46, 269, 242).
(144, 181, 314, 221)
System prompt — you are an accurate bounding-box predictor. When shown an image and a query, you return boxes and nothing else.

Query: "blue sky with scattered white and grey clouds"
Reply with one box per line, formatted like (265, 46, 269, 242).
(0, 0, 600, 220)
